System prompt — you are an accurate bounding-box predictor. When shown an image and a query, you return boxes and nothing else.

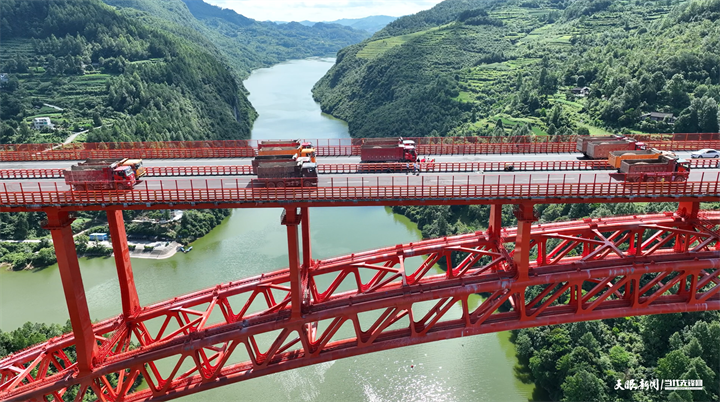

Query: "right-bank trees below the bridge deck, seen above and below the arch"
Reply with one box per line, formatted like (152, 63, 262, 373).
(393, 199, 720, 402)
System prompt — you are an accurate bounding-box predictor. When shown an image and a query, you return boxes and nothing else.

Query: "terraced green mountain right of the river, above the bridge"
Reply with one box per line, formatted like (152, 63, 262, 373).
(313, 0, 720, 137)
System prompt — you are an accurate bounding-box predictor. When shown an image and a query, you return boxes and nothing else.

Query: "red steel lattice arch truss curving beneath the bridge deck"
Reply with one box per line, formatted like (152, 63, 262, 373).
(0, 214, 720, 401)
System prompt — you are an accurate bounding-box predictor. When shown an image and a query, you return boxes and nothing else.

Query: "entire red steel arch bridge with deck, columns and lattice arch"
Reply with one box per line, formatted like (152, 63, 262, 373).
(0, 139, 720, 401)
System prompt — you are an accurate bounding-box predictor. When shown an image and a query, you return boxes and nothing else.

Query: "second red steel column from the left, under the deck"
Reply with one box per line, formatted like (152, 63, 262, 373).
(107, 210, 140, 318)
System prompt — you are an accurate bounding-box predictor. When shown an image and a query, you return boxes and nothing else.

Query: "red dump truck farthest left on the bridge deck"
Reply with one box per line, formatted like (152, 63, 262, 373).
(65, 160, 138, 191)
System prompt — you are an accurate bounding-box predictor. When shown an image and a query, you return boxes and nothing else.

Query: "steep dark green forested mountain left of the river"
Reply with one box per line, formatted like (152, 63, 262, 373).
(0, 0, 255, 143)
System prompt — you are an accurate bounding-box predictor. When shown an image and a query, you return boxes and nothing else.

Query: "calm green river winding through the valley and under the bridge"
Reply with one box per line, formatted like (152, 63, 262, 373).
(0, 59, 534, 402)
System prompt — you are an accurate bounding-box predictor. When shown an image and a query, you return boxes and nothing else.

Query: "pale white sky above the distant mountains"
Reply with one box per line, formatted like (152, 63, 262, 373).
(205, 0, 442, 21)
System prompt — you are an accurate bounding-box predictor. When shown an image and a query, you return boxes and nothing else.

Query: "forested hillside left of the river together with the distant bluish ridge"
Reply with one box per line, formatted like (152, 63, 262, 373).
(0, 0, 368, 143)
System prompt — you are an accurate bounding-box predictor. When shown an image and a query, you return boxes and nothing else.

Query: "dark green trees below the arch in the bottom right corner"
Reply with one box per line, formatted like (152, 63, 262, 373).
(513, 311, 720, 402)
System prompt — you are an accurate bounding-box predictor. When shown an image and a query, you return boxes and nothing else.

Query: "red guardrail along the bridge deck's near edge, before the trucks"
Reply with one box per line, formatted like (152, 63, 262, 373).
(0, 173, 720, 208)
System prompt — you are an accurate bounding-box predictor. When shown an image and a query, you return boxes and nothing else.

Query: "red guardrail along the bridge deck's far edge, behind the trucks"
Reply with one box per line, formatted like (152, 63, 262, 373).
(0, 133, 720, 162)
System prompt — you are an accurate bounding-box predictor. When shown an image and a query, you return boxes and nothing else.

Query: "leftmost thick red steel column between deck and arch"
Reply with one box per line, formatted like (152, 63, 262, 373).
(45, 209, 97, 373)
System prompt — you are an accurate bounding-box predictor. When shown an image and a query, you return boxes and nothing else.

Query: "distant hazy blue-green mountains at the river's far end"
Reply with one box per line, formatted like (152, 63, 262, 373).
(105, 0, 369, 78)
